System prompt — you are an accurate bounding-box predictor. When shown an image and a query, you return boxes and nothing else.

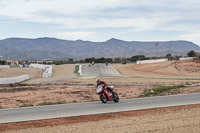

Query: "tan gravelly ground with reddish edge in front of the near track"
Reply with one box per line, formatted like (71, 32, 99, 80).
(0, 104, 200, 133)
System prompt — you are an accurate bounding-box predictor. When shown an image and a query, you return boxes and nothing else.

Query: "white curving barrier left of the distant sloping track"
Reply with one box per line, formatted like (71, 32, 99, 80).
(29, 64, 53, 78)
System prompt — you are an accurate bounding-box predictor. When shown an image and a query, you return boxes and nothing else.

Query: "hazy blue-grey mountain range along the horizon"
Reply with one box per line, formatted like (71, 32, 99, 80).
(0, 37, 200, 60)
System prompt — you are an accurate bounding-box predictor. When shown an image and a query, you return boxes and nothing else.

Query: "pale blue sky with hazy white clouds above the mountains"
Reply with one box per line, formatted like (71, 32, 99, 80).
(0, 0, 200, 45)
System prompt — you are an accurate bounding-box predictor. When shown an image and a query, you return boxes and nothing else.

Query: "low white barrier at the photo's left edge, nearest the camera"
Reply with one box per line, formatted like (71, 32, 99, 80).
(0, 75, 29, 84)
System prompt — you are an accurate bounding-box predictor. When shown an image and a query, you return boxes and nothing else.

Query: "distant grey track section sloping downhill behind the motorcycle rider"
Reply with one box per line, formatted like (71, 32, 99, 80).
(80, 63, 121, 77)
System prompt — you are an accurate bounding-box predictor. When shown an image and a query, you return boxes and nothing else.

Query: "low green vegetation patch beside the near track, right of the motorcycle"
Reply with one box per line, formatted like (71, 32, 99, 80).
(141, 85, 185, 97)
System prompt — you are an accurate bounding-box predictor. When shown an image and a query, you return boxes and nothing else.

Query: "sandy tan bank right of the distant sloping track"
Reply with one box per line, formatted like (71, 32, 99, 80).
(114, 60, 200, 77)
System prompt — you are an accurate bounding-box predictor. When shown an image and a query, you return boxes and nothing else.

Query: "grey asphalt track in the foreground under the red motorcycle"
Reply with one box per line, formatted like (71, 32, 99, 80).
(0, 93, 200, 124)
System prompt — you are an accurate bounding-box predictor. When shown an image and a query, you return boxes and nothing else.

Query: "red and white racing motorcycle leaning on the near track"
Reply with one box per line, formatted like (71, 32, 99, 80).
(97, 85, 119, 103)
